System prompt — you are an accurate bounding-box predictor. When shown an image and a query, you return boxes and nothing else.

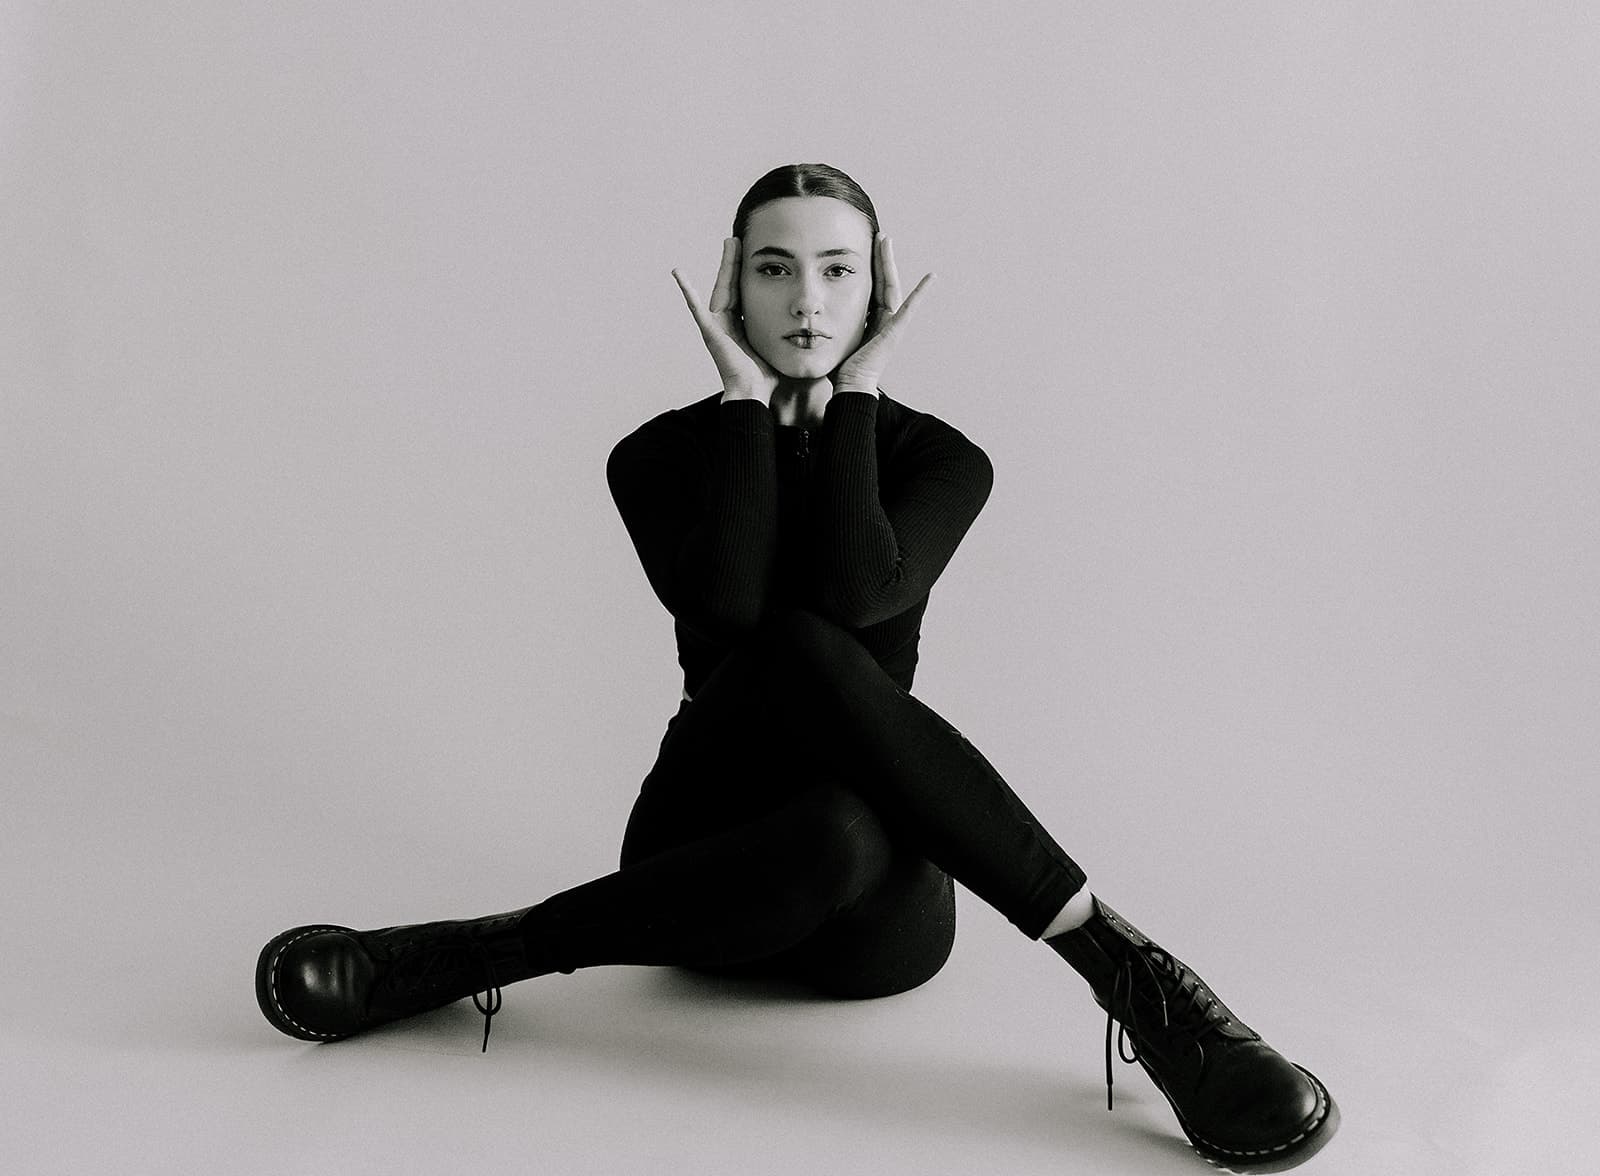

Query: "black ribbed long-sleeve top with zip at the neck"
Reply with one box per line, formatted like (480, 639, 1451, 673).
(606, 392, 994, 694)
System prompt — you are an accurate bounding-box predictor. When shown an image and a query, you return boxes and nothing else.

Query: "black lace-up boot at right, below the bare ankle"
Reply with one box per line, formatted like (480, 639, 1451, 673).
(1046, 898, 1339, 1171)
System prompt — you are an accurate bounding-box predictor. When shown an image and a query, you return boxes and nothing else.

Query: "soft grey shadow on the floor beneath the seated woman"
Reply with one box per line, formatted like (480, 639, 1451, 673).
(236, 968, 1198, 1171)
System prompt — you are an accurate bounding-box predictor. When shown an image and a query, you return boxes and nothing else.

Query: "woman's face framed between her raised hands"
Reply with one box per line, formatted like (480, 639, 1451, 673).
(739, 197, 872, 379)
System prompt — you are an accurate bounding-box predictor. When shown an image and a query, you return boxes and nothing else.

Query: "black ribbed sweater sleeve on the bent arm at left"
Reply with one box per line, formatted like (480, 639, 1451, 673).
(606, 400, 778, 640)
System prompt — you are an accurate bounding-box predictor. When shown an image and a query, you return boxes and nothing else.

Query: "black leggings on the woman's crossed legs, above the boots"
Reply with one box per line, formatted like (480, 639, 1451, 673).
(523, 610, 1085, 997)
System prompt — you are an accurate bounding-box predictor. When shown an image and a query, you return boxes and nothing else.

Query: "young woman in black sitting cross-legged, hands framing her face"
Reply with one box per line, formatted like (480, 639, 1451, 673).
(256, 165, 1339, 1168)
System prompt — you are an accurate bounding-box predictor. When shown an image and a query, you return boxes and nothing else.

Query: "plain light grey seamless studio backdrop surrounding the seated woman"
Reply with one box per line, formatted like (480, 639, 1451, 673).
(0, 3, 1600, 1173)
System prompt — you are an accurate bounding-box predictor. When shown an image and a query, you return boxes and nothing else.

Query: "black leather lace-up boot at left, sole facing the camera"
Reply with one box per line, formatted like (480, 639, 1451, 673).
(256, 909, 528, 1050)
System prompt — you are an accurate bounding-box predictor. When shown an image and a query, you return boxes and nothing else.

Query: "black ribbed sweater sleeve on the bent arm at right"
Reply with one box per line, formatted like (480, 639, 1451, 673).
(811, 392, 994, 629)
